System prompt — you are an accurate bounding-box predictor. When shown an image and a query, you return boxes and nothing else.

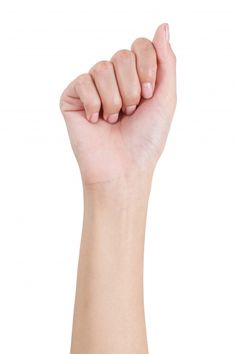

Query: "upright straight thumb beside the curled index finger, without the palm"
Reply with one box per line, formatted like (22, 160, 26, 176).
(150, 23, 176, 113)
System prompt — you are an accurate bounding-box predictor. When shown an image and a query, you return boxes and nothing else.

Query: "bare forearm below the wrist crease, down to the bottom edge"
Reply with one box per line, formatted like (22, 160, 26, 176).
(71, 177, 151, 354)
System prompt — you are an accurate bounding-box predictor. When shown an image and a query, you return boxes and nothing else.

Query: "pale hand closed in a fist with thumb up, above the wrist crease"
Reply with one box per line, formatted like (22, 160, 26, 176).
(60, 24, 176, 185)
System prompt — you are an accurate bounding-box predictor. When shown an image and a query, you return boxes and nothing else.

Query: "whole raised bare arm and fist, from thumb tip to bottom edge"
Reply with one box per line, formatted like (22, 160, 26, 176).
(60, 23, 176, 354)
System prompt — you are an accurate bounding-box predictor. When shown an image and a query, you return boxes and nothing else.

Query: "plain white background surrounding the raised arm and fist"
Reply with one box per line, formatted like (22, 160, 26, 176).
(0, 0, 236, 354)
